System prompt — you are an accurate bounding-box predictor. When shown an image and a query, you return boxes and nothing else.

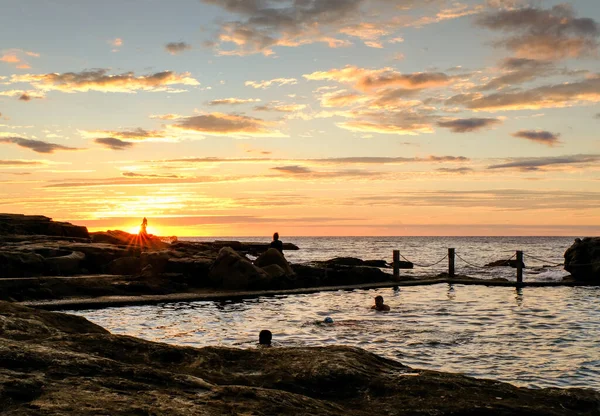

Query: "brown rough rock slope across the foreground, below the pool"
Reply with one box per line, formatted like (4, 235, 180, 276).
(0, 302, 600, 416)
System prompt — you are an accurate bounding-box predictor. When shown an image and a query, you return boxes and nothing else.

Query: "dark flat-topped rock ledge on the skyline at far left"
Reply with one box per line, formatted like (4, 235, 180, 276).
(0, 214, 90, 238)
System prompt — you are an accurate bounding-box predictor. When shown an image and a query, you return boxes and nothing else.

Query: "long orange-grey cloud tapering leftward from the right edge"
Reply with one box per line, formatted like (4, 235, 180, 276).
(446, 75, 600, 112)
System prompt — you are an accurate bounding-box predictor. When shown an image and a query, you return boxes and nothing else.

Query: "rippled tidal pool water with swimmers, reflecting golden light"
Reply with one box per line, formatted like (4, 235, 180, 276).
(71, 284, 600, 389)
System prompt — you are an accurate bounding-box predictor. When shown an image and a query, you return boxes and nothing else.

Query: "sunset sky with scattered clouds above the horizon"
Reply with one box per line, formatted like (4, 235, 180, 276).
(0, 0, 600, 240)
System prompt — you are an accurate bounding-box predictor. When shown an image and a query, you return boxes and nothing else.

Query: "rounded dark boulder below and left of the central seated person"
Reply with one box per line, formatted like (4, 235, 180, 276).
(209, 247, 271, 290)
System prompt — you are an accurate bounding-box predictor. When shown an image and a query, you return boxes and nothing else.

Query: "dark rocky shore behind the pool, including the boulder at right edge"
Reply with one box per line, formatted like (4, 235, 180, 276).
(0, 214, 600, 303)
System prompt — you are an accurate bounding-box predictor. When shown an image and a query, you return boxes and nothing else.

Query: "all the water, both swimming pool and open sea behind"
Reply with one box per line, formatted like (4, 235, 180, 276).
(70, 237, 600, 390)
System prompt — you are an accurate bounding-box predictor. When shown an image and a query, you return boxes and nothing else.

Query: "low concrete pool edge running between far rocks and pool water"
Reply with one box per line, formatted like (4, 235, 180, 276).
(21, 278, 598, 311)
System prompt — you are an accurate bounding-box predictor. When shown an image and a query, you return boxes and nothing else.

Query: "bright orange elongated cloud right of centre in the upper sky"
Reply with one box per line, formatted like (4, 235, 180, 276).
(303, 65, 452, 90)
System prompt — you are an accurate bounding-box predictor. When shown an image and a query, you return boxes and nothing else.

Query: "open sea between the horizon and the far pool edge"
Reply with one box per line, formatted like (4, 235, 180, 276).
(181, 236, 575, 281)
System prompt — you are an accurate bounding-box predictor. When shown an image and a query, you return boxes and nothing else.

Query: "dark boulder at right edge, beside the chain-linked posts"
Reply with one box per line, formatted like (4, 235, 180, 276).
(565, 237, 600, 283)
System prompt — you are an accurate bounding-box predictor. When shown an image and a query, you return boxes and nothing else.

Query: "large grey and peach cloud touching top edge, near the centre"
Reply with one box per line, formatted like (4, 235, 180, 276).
(202, 0, 470, 56)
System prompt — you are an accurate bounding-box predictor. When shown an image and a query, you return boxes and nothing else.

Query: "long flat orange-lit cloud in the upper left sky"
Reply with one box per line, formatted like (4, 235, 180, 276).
(11, 69, 200, 93)
